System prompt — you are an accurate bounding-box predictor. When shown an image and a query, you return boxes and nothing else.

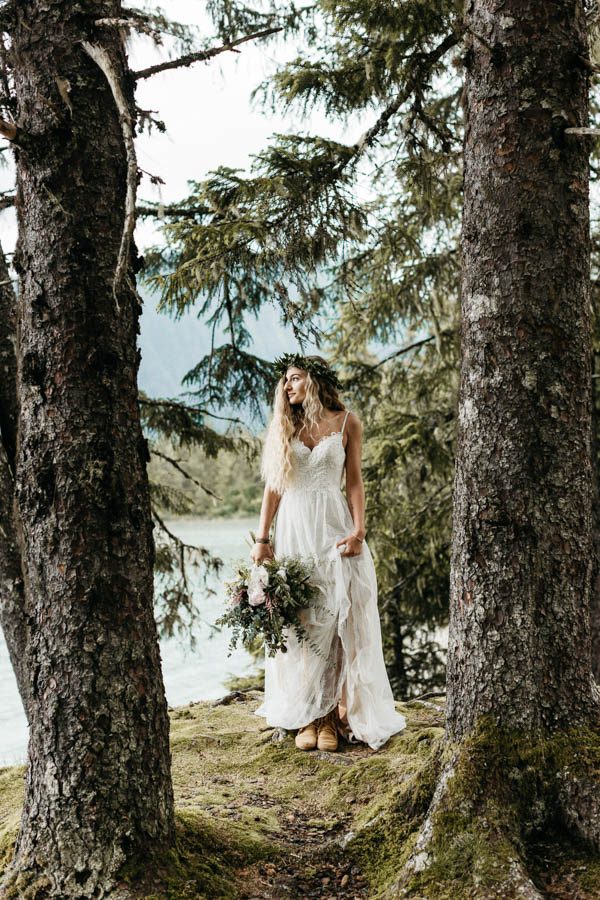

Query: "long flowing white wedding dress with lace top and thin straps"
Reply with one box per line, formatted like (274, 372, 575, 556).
(256, 413, 406, 749)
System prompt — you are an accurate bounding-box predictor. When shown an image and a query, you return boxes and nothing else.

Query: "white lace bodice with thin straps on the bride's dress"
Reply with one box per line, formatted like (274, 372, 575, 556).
(287, 413, 348, 491)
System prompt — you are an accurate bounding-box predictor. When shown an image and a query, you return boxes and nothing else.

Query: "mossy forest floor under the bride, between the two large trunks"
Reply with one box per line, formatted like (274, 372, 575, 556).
(0, 691, 600, 900)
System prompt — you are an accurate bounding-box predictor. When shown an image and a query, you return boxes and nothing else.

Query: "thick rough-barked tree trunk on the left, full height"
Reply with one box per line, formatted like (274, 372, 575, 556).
(1, 0, 174, 898)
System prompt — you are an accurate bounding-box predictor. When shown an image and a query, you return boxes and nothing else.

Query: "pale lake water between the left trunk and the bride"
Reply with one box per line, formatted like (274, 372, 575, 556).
(0, 518, 258, 766)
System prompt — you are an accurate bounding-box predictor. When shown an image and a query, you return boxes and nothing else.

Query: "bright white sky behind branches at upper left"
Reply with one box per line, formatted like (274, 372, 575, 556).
(0, 0, 356, 252)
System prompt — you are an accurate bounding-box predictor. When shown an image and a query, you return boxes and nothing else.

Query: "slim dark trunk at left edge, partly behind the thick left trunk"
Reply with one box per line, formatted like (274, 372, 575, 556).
(0, 239, 31, 718)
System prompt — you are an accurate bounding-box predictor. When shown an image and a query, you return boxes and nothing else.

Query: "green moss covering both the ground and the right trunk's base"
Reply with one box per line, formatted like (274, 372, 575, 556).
(0, 708, 600, 900)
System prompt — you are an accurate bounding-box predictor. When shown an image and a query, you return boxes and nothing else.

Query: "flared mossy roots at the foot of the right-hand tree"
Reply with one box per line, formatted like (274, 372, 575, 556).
(384, 721, 600, 900)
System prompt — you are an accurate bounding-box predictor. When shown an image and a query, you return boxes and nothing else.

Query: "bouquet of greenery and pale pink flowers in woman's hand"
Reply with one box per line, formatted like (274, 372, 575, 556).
(215, 557, 320, 656)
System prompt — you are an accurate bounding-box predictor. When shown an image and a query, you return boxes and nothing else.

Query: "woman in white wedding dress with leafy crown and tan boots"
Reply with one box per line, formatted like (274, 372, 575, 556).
(250, 353, 406, 751)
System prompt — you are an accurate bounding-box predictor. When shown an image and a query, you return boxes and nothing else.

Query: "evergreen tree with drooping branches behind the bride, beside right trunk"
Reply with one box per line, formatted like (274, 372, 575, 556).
(144, 0, 600, 695)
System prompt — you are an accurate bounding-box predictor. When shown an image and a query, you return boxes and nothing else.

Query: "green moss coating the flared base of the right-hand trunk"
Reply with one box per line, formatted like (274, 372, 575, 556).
(406, 719, 600, 900)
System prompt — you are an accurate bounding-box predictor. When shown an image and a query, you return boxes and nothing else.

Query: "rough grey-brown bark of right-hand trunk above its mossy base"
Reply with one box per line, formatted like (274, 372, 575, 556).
(448, 0, 597, 739)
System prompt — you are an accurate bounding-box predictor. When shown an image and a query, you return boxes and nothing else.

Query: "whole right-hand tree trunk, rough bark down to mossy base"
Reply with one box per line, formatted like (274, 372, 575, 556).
(403, 0, 600, 898)
